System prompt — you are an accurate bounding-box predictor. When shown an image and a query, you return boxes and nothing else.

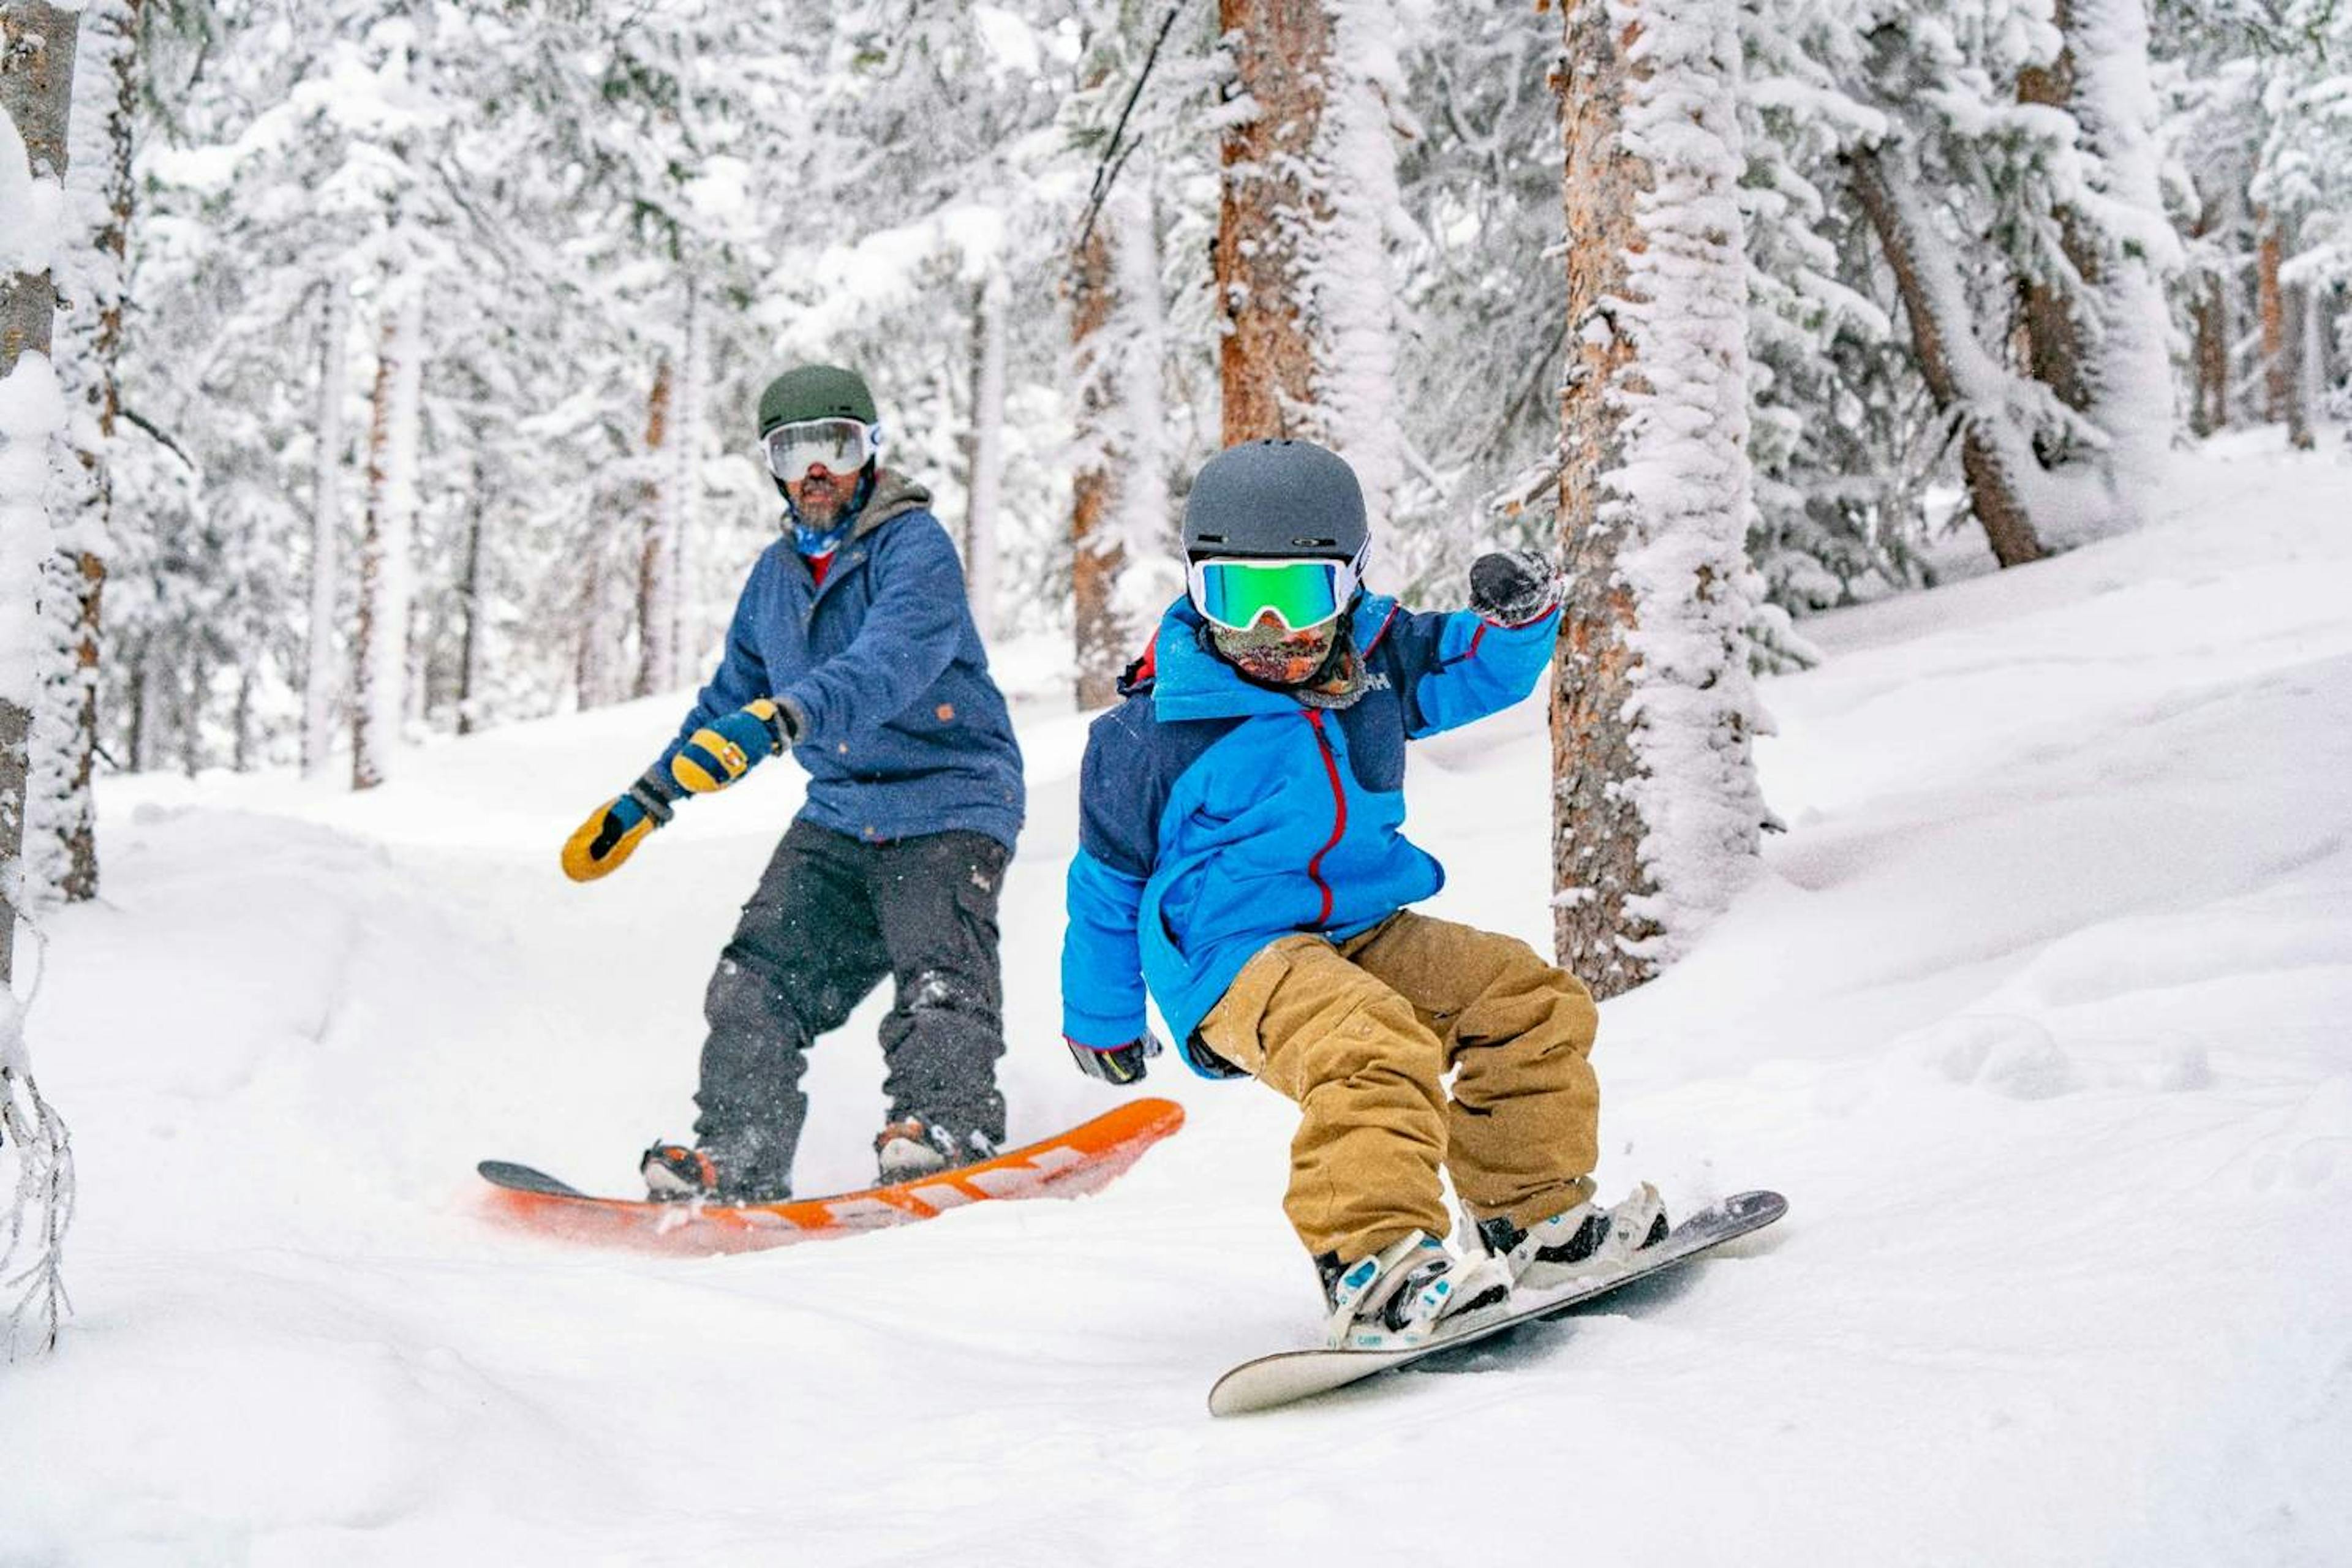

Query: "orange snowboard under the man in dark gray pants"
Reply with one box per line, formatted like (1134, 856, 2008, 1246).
(475, 1100, 1183, 1256)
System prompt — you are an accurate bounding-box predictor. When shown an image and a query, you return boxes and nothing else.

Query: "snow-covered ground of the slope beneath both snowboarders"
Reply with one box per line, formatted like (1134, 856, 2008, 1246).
(0, 442, 2352, 1568)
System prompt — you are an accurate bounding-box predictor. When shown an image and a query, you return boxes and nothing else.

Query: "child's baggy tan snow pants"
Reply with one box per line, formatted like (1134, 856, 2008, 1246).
(1199, 912, 1599, 1262)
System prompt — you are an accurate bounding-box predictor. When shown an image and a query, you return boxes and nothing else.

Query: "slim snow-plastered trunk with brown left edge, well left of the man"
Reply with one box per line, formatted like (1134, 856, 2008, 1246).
(350, 282, 423, 790)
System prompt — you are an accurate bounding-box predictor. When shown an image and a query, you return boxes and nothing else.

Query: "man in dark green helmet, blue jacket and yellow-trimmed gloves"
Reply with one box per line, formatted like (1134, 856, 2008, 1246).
(565, 364, 1023, 1204)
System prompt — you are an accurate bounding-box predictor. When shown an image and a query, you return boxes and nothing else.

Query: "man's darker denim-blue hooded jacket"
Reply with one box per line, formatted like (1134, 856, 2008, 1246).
(656, 470, 1023, 849)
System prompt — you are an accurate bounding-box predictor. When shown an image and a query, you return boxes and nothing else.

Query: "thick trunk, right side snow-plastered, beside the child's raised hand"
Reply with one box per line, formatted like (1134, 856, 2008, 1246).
(1552, 0, 1764, 997)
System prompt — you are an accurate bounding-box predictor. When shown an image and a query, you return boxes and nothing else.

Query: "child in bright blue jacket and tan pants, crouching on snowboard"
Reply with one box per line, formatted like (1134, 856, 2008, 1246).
(1061, 442, 1665, 1347)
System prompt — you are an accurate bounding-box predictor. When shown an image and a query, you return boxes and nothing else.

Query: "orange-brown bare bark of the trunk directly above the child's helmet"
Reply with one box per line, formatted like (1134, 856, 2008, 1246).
(1212, 0, 1331, 447)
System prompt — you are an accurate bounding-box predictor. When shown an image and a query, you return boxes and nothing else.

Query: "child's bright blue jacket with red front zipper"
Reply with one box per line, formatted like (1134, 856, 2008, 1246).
(1061, 595, 1559, 1077)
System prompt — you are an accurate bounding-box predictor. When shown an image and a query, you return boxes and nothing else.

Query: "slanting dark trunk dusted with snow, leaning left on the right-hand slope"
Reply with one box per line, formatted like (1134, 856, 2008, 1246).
(1846, 148, 2044, 567)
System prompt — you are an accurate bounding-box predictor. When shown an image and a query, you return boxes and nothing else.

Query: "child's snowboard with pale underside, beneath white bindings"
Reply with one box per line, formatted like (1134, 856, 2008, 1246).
(1209, 1192, 1787, 1415)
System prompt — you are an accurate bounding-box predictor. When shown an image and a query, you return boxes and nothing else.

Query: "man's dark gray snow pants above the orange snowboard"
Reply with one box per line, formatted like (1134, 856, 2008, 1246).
(694, 820, 1009, 1185)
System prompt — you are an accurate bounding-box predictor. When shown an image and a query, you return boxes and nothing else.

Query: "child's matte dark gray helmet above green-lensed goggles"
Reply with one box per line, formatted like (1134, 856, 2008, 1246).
(1183, 440, 1366, 562)
